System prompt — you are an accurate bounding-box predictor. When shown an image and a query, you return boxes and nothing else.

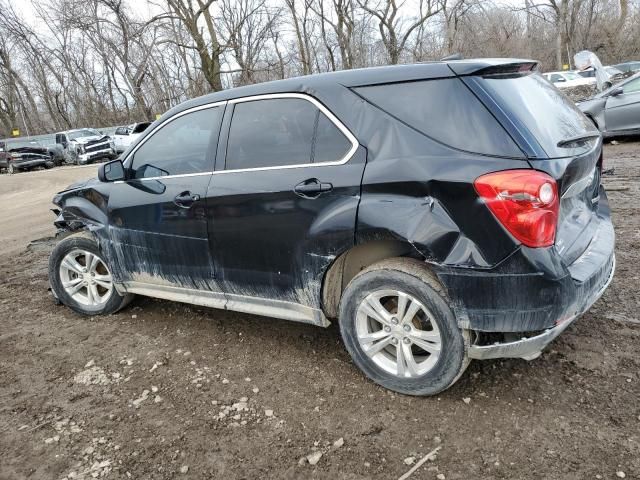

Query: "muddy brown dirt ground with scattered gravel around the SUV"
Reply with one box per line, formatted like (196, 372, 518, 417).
(0, 145, 640, 480)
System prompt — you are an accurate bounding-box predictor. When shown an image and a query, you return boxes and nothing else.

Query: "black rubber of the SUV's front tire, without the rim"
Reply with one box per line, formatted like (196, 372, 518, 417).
(49, 232, 133, 316)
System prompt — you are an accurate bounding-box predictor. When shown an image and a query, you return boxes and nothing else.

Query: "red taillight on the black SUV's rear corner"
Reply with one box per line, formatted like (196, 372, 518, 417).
(474, 170, 559, 247)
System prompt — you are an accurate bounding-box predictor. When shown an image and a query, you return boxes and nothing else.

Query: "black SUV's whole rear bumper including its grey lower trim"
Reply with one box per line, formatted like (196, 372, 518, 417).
(438, 190, 615, 359)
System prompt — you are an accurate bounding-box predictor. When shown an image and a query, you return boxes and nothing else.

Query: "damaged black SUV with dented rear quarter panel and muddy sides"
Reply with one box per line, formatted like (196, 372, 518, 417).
(49, 59, 615, 395)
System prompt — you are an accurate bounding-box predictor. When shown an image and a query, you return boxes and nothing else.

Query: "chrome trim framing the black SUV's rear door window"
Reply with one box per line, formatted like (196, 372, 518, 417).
(219, 92, 360, 175)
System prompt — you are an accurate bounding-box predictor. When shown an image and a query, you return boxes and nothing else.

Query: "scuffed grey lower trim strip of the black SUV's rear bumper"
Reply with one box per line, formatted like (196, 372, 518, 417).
(468, 256, 615, 360)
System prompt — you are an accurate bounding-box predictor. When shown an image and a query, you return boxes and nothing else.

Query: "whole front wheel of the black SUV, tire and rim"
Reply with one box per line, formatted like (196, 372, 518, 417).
(49, 232, 133, 315)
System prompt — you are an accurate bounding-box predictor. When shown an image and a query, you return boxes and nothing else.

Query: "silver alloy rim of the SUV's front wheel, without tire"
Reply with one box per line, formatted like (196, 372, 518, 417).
(60, 249, 113, 307)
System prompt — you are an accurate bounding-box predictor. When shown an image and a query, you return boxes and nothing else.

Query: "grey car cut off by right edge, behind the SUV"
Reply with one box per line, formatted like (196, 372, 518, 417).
(577, 72, 640, 137)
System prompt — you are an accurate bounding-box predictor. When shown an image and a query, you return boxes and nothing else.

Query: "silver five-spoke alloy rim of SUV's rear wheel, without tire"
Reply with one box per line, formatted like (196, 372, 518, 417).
(356, 290, 442, 378)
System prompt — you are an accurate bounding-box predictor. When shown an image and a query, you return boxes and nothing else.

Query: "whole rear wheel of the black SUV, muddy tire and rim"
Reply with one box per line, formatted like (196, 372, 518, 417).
(339, 258, 469, 395)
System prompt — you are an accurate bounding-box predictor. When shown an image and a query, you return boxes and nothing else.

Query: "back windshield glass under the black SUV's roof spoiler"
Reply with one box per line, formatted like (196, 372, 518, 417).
(481, 73, 597, 158)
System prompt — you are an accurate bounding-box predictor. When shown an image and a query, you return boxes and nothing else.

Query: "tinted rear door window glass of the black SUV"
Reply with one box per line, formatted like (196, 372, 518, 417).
(225, 98, 351, 170)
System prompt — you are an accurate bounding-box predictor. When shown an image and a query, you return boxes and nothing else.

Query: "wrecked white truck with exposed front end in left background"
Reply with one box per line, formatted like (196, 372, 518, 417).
(56, 128, 118, 165)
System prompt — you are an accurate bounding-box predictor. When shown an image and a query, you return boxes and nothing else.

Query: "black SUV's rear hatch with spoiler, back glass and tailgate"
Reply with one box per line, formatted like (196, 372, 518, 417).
(464, 63, 613, 272)
